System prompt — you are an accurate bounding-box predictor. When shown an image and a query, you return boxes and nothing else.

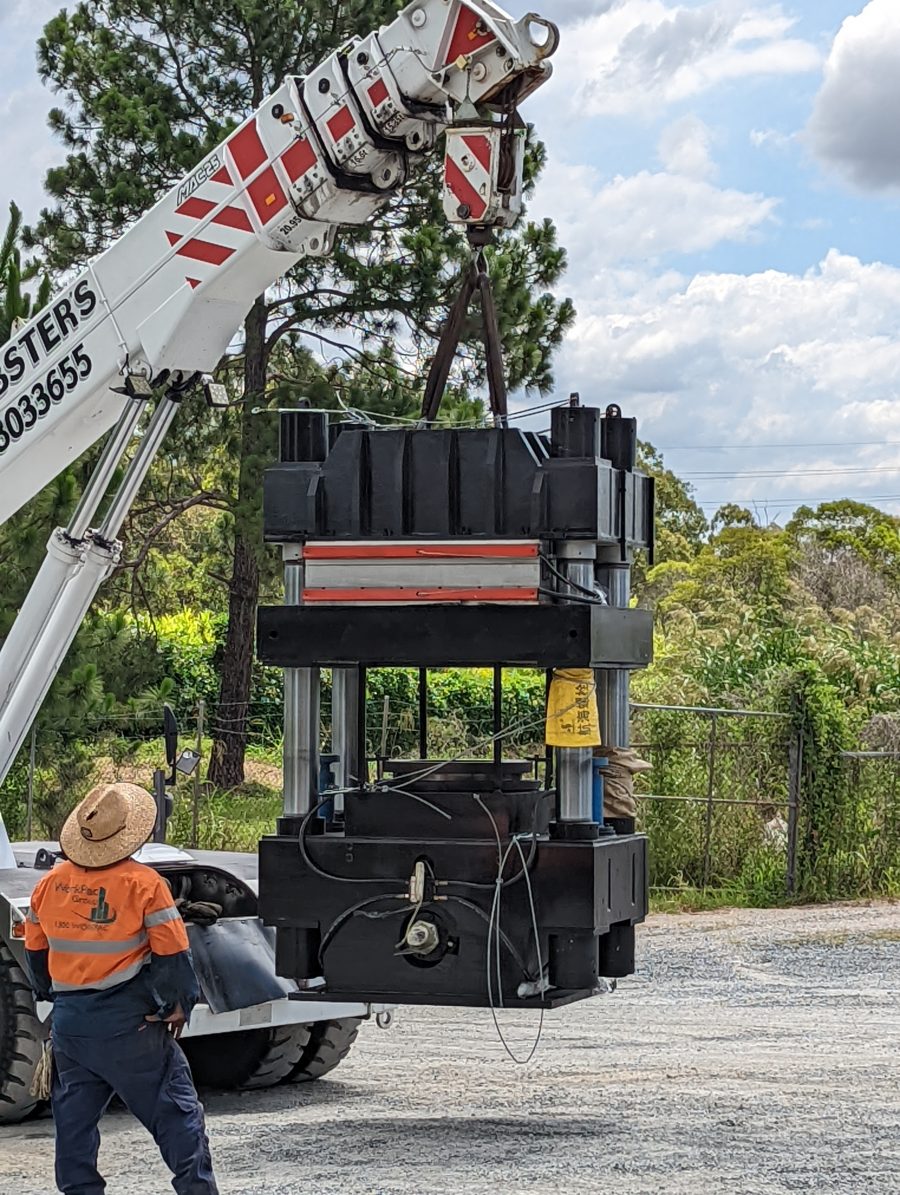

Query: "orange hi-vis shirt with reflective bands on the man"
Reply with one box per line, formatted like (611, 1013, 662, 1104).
(25, 859, 189, 993)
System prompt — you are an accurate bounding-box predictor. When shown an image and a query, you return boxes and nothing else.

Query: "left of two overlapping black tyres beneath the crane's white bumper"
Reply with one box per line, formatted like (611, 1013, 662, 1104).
(182, 1025, 310, 1091)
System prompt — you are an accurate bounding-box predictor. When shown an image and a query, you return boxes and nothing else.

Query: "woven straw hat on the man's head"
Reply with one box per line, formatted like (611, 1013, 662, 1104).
(60, 784, 157, 868)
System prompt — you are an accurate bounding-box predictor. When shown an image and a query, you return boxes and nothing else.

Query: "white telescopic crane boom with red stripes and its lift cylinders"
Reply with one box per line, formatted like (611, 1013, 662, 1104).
(0, 0, 558, 812)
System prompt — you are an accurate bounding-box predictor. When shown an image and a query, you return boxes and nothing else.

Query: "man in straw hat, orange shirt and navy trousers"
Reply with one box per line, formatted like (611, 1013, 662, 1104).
(25, 784, 218, 1195)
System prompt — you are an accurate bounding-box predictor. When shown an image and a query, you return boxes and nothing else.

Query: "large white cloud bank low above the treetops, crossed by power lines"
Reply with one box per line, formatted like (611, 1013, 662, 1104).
(537, 250, 900, 500)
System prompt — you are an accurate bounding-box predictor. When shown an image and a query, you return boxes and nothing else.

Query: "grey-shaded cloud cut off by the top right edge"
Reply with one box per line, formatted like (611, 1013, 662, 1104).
(809, 0, 900, 190)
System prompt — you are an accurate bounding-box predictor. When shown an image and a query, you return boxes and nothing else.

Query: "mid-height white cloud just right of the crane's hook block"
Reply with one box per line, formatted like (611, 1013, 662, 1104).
(531, 155, 778, 272)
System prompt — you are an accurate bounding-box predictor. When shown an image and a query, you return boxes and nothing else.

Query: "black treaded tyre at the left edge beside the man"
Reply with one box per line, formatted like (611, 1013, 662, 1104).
(0, 942, 44, 1124)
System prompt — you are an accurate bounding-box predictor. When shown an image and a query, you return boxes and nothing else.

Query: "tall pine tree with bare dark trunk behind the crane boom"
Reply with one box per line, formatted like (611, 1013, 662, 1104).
(29, 0, 574, 788)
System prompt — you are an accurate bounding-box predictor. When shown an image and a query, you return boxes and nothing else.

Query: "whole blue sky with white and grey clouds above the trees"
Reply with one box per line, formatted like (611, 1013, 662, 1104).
(0, 0, 900, 522)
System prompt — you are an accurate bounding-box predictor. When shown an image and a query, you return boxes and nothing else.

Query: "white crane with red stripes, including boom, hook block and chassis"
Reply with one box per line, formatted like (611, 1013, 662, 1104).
(0, 0, 557, 1121)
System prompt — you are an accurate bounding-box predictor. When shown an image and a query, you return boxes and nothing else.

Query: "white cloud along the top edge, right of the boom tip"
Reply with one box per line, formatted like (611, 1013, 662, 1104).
(547, 0, 821, 116)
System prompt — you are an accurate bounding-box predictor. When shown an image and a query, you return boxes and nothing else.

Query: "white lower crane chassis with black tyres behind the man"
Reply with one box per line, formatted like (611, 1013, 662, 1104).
(0, 842, 392, 1124)
